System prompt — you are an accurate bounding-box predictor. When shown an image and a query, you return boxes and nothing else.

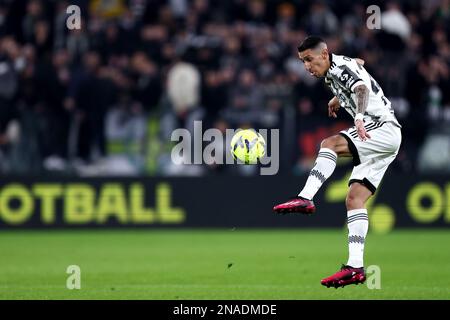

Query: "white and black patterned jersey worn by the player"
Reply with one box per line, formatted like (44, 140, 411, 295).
(325, 54, 401, 127)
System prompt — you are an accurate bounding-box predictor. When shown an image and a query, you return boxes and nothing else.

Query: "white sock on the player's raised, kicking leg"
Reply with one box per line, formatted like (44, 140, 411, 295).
(298, 148, 337, 200)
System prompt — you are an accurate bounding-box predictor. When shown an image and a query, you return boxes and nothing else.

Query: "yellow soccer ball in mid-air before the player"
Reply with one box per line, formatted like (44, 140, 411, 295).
(231, 129, 266, 164)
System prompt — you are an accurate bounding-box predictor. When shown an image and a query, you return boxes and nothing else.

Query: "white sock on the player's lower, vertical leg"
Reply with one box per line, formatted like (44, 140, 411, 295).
(347, 209, 369, 268)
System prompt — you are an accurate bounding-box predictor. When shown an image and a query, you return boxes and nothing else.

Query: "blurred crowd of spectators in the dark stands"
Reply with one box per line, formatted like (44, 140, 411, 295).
(0, 0, 450, 175)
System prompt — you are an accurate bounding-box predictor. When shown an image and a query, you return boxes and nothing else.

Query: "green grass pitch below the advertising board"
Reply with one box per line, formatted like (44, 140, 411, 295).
(0, 229, 450, 300)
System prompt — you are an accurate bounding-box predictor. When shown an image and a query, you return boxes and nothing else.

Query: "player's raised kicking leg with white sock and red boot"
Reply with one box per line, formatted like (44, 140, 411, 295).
(273, 135, 351, 214)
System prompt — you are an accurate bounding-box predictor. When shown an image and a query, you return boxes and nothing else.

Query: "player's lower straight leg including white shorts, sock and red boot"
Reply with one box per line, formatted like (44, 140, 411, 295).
(321, 123, 401, 288)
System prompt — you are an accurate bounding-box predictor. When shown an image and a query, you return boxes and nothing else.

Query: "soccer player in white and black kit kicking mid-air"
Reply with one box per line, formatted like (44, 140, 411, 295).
(273, 36, 401, 288)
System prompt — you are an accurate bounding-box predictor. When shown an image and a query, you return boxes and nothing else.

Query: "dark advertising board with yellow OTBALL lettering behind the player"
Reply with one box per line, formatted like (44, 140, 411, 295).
(0, 172, 450, 232)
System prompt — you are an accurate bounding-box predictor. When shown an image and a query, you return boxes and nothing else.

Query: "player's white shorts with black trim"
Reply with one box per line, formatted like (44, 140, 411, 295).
(340, 122, 402, 194)
